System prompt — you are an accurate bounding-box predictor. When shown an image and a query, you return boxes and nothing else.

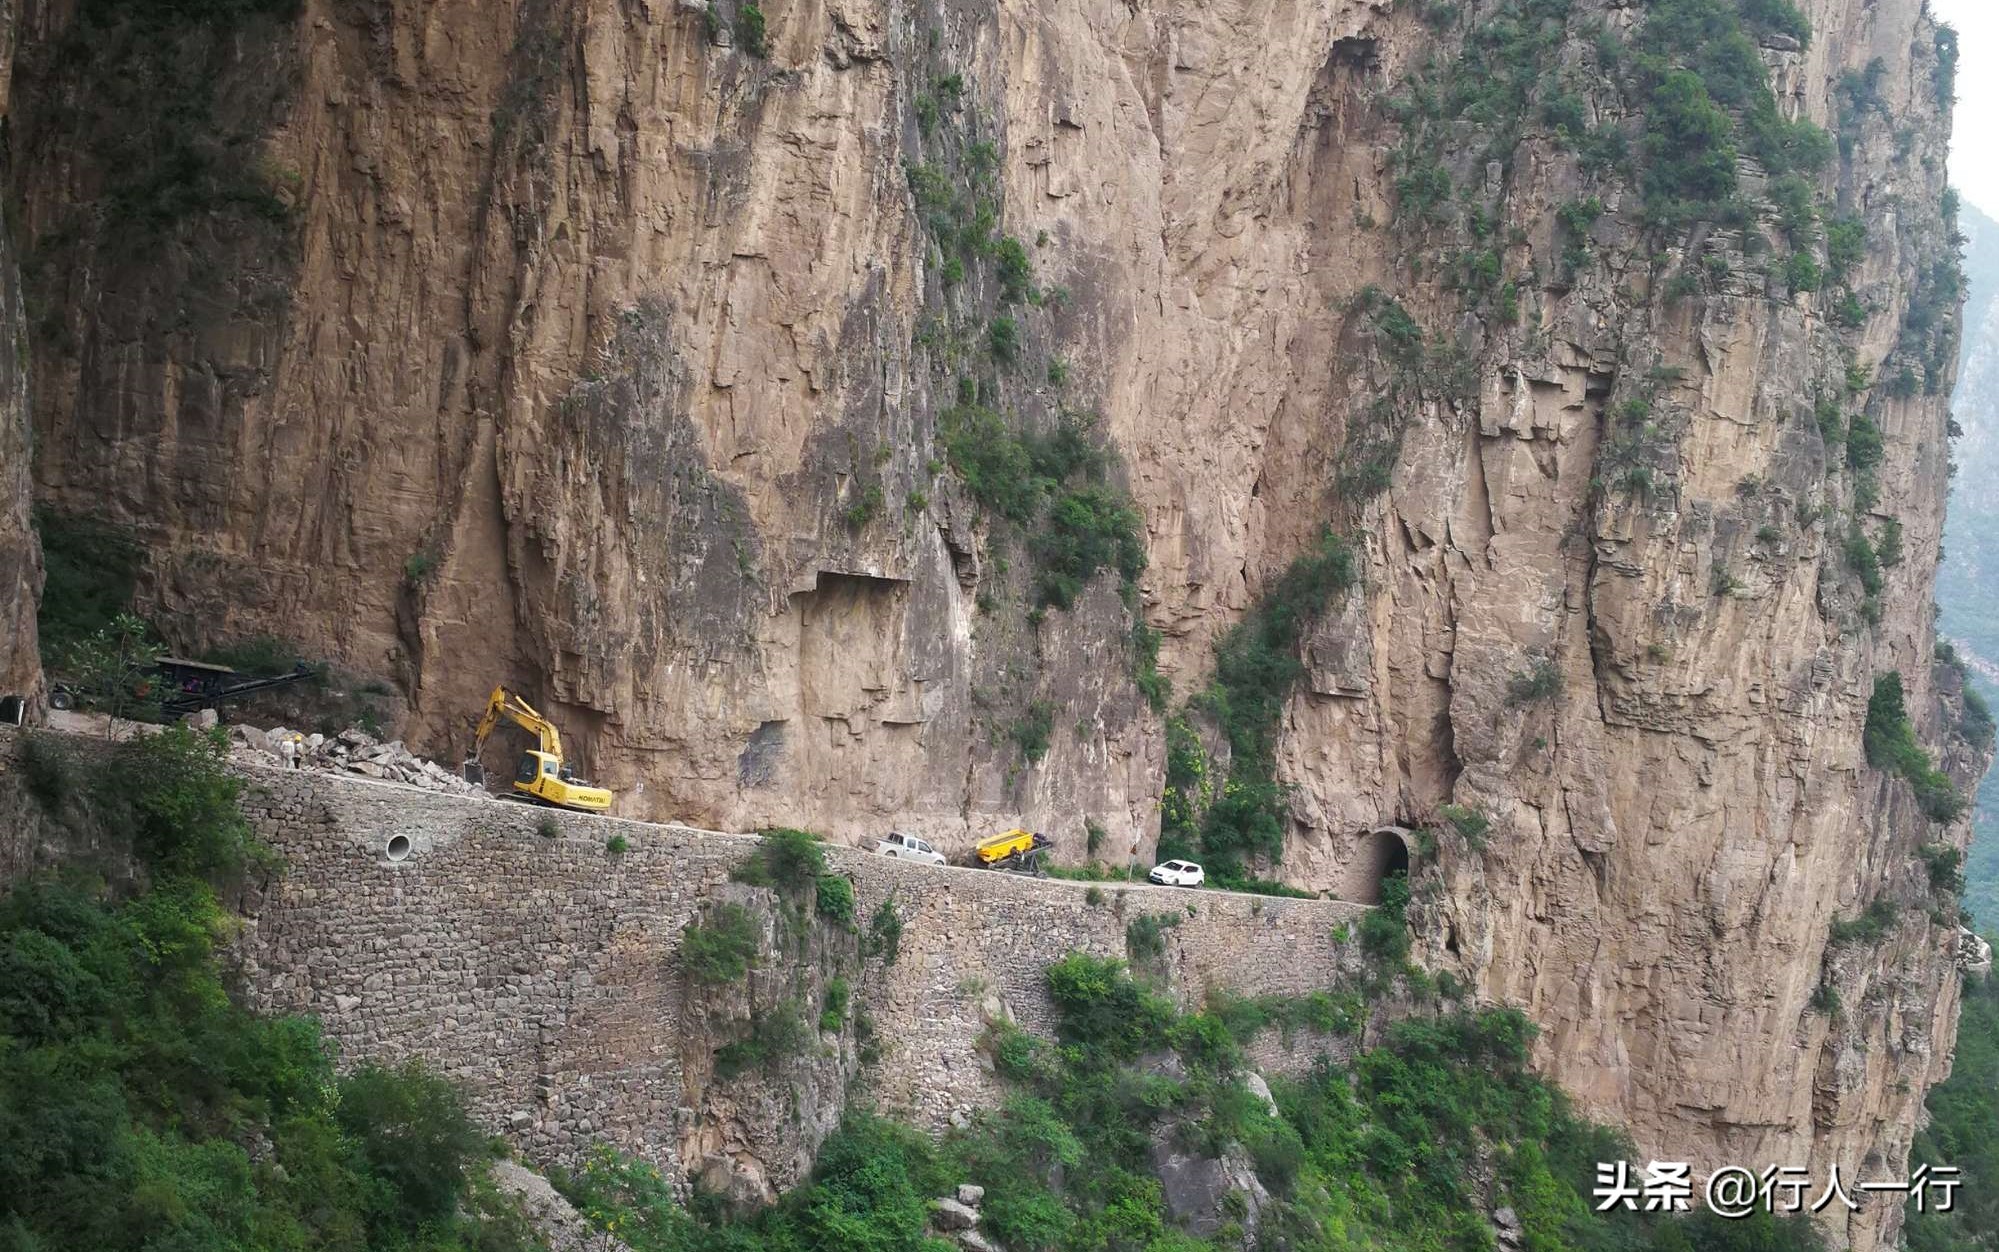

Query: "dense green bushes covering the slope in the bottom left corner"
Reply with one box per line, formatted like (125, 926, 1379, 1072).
(0, 730, 536, 1252)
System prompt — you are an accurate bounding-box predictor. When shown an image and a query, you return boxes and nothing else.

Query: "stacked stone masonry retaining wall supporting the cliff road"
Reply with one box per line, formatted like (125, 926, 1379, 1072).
(222, 770, 1365, 1186)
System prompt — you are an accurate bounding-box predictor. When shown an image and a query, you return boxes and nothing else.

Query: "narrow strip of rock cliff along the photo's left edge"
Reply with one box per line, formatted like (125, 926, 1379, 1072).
(0, 4, 42, 722)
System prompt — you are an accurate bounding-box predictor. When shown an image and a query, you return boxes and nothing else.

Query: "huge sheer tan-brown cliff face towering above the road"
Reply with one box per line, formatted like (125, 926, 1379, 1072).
(14, 0, 1983, 1246)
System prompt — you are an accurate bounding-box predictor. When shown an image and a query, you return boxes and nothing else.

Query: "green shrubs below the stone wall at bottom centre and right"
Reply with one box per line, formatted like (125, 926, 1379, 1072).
(558, 954, 1823, 1252)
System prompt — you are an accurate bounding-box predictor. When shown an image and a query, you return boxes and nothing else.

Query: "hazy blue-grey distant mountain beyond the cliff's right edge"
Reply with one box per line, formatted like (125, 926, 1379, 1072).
(1937, 204, 1999, 930)
